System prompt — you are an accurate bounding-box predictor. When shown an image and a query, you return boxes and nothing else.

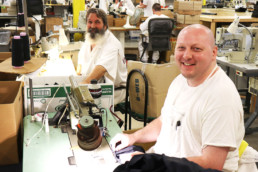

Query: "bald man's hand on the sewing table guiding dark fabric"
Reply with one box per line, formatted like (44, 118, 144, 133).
(110, 133, 134, 151)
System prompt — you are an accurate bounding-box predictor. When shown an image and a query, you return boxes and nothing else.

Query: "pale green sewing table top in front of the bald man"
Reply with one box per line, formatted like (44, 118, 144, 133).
(22, 110, 122, 172)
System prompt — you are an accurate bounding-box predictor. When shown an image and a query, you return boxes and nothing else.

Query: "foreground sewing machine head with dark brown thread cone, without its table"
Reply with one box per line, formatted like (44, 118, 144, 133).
(69, 76, 103, 150)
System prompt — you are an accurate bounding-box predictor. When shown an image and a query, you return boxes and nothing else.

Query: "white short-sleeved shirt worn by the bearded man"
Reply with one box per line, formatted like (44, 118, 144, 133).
(78, 30, 127, 104)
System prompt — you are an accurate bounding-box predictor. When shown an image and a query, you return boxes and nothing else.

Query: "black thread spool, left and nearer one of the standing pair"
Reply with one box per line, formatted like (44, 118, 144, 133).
(12, 36, 24, 68)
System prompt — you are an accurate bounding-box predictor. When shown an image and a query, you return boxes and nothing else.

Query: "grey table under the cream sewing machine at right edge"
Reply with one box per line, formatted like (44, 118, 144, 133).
(217, 57, 258, 133)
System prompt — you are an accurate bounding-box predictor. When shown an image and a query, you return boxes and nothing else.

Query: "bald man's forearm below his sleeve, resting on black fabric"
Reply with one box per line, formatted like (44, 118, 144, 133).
(187, 146, 229, 171)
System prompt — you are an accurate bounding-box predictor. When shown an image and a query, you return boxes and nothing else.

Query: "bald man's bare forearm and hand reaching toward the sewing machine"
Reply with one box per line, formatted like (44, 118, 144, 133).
(110, 117, 162, 151)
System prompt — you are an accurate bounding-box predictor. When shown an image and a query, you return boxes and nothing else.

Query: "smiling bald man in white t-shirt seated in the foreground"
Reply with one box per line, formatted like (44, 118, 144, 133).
(111, 24, 248, 172)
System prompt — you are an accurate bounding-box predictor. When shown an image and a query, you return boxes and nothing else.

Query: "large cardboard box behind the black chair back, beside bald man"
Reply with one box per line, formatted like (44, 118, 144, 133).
(127, 61, 180, 117)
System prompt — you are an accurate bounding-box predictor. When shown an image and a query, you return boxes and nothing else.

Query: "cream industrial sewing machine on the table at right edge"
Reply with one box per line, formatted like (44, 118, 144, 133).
(216, 27, 258, 63)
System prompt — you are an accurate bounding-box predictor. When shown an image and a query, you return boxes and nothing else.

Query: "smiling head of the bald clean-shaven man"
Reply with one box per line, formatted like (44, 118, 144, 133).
(175, 24, 217, 86)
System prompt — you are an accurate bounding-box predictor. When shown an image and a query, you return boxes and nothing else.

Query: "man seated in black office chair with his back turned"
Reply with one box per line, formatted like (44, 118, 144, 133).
(138, 3, 168, 63)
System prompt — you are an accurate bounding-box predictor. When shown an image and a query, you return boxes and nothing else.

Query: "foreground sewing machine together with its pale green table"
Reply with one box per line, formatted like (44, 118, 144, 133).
(23, 77, 122, 172)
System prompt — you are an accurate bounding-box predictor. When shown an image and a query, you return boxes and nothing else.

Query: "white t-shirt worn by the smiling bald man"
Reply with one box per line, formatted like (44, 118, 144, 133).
(150, 68, 245, 171)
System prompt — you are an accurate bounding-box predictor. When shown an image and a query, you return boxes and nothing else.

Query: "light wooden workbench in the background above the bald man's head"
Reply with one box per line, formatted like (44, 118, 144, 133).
(200, 8, 258, 36)
